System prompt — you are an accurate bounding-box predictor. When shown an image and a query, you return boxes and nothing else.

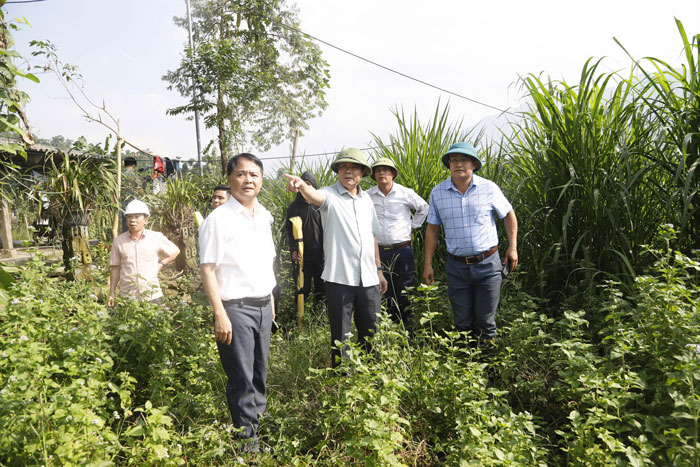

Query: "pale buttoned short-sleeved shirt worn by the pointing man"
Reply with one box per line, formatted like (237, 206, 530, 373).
(318, 182, 379, 287)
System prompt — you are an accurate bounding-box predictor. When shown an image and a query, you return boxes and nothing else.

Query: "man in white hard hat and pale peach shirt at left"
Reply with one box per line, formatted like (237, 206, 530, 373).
(107, 199, 180, 306)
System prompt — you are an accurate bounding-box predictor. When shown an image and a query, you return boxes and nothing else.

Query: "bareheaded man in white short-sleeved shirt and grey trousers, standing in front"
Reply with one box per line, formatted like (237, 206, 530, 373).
(199, 153, 276, 451)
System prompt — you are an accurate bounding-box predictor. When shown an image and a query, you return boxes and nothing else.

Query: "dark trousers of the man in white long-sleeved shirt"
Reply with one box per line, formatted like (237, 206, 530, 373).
(379, 245, 414, 327)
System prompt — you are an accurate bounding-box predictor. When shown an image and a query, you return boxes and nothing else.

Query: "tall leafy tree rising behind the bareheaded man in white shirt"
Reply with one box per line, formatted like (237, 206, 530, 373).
(163, 0, 329, 176)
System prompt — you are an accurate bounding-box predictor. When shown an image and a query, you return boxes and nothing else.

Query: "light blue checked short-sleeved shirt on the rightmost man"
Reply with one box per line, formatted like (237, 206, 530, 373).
(428, 174, 513, 256)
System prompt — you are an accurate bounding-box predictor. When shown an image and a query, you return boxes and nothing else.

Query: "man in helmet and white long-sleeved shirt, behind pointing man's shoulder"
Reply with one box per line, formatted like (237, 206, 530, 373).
(367, 157, 428, 328)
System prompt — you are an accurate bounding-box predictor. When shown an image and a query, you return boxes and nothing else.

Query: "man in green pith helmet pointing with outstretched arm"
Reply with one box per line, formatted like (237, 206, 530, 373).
(285, 148, 387, 366)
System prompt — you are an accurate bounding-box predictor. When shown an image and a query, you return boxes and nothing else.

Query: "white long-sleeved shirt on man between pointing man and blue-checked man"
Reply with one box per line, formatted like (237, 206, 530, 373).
(367, 183, 428, 245)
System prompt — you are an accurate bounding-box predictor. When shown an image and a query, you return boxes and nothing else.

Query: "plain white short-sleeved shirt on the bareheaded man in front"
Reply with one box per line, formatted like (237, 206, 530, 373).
(199, 196, 276, 300)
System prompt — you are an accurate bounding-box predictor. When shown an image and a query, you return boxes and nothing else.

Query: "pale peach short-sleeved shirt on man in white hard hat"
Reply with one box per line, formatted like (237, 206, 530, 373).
(109, 229, 178, 300)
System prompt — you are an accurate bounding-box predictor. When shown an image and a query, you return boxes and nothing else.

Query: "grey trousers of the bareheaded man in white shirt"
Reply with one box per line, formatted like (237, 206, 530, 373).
(217, 300, 272, 438)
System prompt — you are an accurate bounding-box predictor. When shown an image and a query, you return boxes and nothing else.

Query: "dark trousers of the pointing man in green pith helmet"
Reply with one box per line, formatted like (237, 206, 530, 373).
(326, 282, 382, 367)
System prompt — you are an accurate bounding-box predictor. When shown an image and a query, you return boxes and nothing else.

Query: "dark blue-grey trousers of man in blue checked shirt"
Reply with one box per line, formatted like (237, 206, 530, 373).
(445, 252, 503, 339)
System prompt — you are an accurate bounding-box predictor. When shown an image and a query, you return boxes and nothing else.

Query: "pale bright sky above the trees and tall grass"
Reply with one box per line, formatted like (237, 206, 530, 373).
(4, 0, 700, 173)
